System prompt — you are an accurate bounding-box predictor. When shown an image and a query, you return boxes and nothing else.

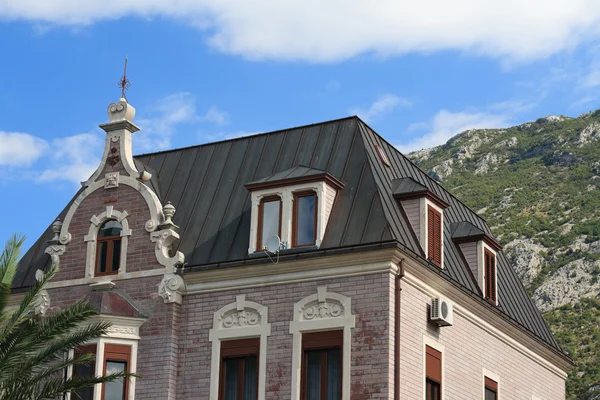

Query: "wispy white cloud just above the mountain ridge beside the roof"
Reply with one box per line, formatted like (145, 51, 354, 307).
(397, 110, 513, 153)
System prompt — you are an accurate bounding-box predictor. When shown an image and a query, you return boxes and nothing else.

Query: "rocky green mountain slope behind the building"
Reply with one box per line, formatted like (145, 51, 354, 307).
(408, 110, 600, 399)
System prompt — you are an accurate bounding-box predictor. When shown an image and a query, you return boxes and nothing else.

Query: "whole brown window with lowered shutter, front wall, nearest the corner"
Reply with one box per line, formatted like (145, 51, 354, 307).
(300, 330, 343, 400)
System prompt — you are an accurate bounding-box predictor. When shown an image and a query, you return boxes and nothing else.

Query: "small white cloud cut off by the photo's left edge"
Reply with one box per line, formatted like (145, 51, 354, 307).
(0, 131, 48, 167)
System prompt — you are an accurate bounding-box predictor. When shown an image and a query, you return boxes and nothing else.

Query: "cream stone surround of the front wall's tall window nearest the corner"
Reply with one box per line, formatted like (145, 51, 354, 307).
(290, 286, 356, 400)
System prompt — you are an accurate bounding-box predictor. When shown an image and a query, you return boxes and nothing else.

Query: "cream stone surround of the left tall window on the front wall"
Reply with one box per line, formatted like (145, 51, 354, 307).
(208, 294, 271, 400)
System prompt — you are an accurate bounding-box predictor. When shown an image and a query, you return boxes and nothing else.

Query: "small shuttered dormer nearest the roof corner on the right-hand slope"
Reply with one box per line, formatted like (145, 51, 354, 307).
(392, 178, 448, 268)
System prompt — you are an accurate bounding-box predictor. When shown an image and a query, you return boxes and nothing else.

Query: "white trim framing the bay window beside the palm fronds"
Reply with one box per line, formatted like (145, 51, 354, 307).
(65, 315, 146, 400)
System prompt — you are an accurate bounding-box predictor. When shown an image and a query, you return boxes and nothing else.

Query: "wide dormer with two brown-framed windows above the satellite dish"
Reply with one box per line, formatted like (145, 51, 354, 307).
(246, 166, 343, 253)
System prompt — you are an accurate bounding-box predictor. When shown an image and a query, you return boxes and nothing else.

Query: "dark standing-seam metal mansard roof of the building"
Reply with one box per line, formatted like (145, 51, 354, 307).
(15, 117, 560, 351)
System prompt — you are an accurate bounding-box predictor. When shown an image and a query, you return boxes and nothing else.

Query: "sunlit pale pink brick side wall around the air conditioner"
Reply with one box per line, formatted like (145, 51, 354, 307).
(400, 282, 565, 400)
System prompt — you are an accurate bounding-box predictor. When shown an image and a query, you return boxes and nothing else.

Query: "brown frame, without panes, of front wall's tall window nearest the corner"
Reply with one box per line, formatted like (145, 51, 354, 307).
(300, 329, 344, 400)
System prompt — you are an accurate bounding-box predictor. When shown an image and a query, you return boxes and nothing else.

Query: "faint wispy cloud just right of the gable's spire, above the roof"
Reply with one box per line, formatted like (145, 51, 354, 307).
(133, 92, 229, 153)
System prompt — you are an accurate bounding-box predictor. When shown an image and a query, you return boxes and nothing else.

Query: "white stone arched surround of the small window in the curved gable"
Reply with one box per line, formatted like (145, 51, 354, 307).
(83, 206, 131, 278)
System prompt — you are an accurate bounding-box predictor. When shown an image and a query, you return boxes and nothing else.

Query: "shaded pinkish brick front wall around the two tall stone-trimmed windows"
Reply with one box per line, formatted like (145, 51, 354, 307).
(178, 274, 393, 400)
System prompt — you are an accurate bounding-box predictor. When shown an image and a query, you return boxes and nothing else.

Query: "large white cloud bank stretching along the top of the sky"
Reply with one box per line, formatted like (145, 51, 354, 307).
(0, 0, 600, 62)
